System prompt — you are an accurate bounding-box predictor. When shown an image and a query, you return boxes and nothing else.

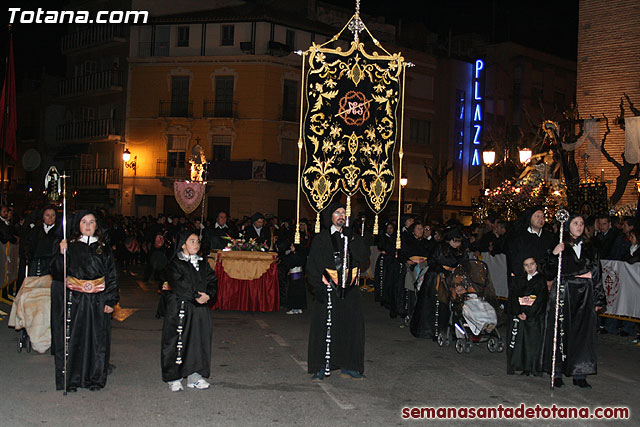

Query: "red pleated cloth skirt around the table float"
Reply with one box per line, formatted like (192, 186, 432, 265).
(212, 261, 280, 311)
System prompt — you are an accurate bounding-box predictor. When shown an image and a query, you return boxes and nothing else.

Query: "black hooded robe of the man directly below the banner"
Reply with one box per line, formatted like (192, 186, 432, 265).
(306, 203, 370, 373)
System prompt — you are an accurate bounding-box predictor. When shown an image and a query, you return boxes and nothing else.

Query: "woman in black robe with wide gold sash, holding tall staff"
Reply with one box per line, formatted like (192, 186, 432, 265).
(51, 211, 120, 391)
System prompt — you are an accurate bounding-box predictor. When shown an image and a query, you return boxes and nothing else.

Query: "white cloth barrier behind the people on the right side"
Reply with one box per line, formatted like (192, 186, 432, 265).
(482, 252, 640, 323)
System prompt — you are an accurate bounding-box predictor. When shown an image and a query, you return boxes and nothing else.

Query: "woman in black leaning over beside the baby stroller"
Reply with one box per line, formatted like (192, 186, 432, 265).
(411, 227, 467, 341)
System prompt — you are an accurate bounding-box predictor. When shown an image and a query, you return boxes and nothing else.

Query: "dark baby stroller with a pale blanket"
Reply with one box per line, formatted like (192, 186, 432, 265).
(438, 260, 504, 353)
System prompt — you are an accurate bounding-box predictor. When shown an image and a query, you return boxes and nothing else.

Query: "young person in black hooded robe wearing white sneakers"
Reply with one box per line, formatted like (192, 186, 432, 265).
(160, 231, 218, 391)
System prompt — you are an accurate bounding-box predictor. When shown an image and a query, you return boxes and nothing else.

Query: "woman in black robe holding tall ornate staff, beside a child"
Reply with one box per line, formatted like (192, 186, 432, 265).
(540, 215, 607, 388)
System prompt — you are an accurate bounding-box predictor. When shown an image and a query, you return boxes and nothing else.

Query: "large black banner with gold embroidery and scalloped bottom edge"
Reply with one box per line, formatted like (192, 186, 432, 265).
(302, 41, 404, 234)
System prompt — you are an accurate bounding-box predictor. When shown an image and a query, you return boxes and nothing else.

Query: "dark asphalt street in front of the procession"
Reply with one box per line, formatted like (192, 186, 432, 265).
(0, 268, 640, 426)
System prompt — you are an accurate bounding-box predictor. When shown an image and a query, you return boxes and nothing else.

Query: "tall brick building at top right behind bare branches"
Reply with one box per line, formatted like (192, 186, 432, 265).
(576, 0, 640, 207)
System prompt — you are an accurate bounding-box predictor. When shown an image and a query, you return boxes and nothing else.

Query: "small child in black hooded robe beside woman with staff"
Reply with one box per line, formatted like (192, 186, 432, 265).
(507, 258, 548, 376)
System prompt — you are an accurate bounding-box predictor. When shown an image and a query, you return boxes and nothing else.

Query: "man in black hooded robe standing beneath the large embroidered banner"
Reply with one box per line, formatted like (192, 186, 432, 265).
(307, 203, 369, 381)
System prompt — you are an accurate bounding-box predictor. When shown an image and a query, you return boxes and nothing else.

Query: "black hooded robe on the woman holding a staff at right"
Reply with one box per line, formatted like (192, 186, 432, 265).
(540, 234, 607, 376)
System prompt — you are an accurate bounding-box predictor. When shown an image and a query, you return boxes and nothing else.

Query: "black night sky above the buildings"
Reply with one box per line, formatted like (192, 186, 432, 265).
(0, 0, 578, 79)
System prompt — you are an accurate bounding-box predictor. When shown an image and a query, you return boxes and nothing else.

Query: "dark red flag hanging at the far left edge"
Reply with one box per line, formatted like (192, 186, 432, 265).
(0, 36, 18, 162)
